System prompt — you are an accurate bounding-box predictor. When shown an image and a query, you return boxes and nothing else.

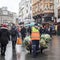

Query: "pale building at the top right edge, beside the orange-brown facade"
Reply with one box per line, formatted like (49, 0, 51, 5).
(54, 0, 60, 22)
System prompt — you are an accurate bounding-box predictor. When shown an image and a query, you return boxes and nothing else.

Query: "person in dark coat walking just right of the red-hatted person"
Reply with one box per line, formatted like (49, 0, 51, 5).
(10, 24, 18, 49)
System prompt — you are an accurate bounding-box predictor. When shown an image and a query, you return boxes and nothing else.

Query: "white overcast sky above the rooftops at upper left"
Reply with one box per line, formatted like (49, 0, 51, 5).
(0, 0, 21, 13)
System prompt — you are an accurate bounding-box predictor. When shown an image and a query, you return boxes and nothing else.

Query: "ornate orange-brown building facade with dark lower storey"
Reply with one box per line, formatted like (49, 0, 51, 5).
(32, 0, 54, 23)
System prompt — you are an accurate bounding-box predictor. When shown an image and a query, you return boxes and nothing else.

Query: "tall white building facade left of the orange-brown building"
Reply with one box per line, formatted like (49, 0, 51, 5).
(19, 0, 32, 23)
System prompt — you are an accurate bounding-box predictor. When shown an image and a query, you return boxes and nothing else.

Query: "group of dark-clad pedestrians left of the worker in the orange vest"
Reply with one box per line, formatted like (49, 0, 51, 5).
(0, 24, 26, 56)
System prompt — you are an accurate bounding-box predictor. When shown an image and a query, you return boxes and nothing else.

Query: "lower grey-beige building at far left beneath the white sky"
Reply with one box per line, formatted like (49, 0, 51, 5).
(0, 7, 16, 24)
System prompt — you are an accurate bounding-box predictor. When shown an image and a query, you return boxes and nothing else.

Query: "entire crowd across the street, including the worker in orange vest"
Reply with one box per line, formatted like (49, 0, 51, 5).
(0, 24, 55, 57)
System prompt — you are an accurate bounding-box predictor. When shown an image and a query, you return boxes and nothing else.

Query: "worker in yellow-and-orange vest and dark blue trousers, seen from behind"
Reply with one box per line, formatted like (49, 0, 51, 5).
(31, 24, 40, 57)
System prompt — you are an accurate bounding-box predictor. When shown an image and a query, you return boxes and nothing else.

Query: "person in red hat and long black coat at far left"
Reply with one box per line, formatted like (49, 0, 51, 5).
(0, 24, 10, 56)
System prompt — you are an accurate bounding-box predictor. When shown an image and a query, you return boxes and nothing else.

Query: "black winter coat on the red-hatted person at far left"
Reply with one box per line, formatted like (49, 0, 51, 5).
(0, 27, 10, 44)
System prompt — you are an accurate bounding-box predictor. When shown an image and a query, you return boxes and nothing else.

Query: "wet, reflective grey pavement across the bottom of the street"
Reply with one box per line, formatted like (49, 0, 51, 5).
(0, 36, 60, 60)
